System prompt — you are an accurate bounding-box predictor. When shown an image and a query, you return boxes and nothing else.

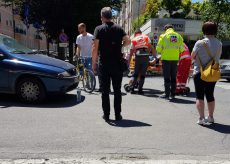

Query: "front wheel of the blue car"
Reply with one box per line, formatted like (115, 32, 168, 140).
(20, 81, 40, 101)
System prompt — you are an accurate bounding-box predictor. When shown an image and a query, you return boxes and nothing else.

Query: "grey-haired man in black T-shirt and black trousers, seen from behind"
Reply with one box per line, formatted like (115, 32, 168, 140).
(93, 7, 131, 122)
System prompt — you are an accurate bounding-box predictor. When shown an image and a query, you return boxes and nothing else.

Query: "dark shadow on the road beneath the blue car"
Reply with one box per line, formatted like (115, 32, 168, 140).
(0, 94, 85, 109)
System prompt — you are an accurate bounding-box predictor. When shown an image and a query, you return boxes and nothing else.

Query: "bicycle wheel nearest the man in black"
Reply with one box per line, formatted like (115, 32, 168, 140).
(83, 69, 96, 93)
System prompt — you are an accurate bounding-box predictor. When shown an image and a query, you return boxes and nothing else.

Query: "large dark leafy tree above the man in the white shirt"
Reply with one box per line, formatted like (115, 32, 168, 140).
(8, 0, 123, 61)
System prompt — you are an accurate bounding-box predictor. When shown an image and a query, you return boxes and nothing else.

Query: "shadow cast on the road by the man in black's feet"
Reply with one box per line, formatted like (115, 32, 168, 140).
(108, 120, 152, 128)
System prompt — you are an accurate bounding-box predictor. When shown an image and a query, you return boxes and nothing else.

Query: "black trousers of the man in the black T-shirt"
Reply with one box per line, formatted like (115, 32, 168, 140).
(99, 66, 123, 116)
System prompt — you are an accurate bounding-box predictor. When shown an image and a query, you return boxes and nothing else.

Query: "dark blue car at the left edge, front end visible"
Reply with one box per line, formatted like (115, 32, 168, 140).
(0, 34, 79, 103)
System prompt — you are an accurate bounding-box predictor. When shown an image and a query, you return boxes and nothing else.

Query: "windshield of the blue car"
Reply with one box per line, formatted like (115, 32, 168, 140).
(0, 35, 32, 54)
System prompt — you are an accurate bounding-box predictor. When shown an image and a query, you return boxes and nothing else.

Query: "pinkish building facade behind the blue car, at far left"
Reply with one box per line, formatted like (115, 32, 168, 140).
(0, 1, 46, 50)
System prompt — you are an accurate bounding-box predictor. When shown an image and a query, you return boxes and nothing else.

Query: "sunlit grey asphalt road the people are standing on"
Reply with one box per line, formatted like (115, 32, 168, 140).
(0, 77, 230, 160)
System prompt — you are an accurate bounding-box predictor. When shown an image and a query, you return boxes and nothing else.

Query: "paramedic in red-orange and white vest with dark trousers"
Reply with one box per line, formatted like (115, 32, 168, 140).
(129, 29, 156, 94)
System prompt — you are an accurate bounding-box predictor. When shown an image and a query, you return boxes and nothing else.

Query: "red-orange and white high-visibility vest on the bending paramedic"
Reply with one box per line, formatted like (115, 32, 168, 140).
(132, 35, 150, 49)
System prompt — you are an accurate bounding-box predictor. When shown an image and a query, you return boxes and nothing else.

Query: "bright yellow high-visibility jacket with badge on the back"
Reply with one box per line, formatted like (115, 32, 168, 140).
(156, 28, 184, 61)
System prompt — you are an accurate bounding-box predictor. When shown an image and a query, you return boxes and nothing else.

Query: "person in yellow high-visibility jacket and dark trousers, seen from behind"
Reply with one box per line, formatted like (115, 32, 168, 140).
(156, 24, 184, 100)
